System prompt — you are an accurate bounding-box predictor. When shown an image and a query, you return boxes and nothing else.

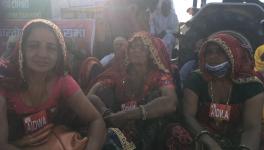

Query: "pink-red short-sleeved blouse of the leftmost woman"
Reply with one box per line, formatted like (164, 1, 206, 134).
(3, 75, 80, 140)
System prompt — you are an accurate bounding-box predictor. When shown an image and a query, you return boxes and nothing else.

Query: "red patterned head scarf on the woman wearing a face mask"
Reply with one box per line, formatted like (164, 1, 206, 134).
(200, 31, 257, 83)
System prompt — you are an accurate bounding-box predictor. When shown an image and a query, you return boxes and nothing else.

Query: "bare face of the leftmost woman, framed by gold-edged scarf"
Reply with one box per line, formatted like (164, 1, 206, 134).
(23, 27, 58, 73)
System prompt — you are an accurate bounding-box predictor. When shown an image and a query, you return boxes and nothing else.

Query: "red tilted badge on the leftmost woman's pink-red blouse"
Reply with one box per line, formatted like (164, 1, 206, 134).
(23, 111, 48, 133)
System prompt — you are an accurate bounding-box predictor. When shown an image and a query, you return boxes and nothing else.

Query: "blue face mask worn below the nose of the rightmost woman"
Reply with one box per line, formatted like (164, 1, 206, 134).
(205, 61, 230, 78)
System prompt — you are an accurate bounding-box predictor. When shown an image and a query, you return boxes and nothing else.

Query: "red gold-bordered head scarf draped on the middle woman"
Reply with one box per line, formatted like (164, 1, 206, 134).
(97, 32, 174, 104)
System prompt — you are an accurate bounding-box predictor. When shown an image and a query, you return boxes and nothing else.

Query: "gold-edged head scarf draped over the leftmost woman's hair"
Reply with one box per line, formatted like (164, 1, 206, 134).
(0, 19, 68, 90)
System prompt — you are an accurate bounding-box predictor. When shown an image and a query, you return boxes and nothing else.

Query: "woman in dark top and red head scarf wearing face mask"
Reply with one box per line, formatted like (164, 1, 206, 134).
(183, 32, 264, 150)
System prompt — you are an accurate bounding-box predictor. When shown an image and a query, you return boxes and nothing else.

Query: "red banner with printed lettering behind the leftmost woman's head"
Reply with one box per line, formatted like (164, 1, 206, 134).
(0, 19, 95, 55)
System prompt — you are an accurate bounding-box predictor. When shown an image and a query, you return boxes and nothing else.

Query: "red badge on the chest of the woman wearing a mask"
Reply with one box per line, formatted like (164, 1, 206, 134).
(209, 103, 231, 121)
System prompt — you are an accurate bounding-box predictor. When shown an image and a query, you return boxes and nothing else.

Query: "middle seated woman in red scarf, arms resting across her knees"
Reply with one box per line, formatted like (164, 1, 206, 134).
(88, 32, 177, 150)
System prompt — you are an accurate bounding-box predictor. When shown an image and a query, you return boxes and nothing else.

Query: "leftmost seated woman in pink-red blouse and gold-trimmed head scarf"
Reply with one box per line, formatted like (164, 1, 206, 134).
(0, 19, 105, 150)
